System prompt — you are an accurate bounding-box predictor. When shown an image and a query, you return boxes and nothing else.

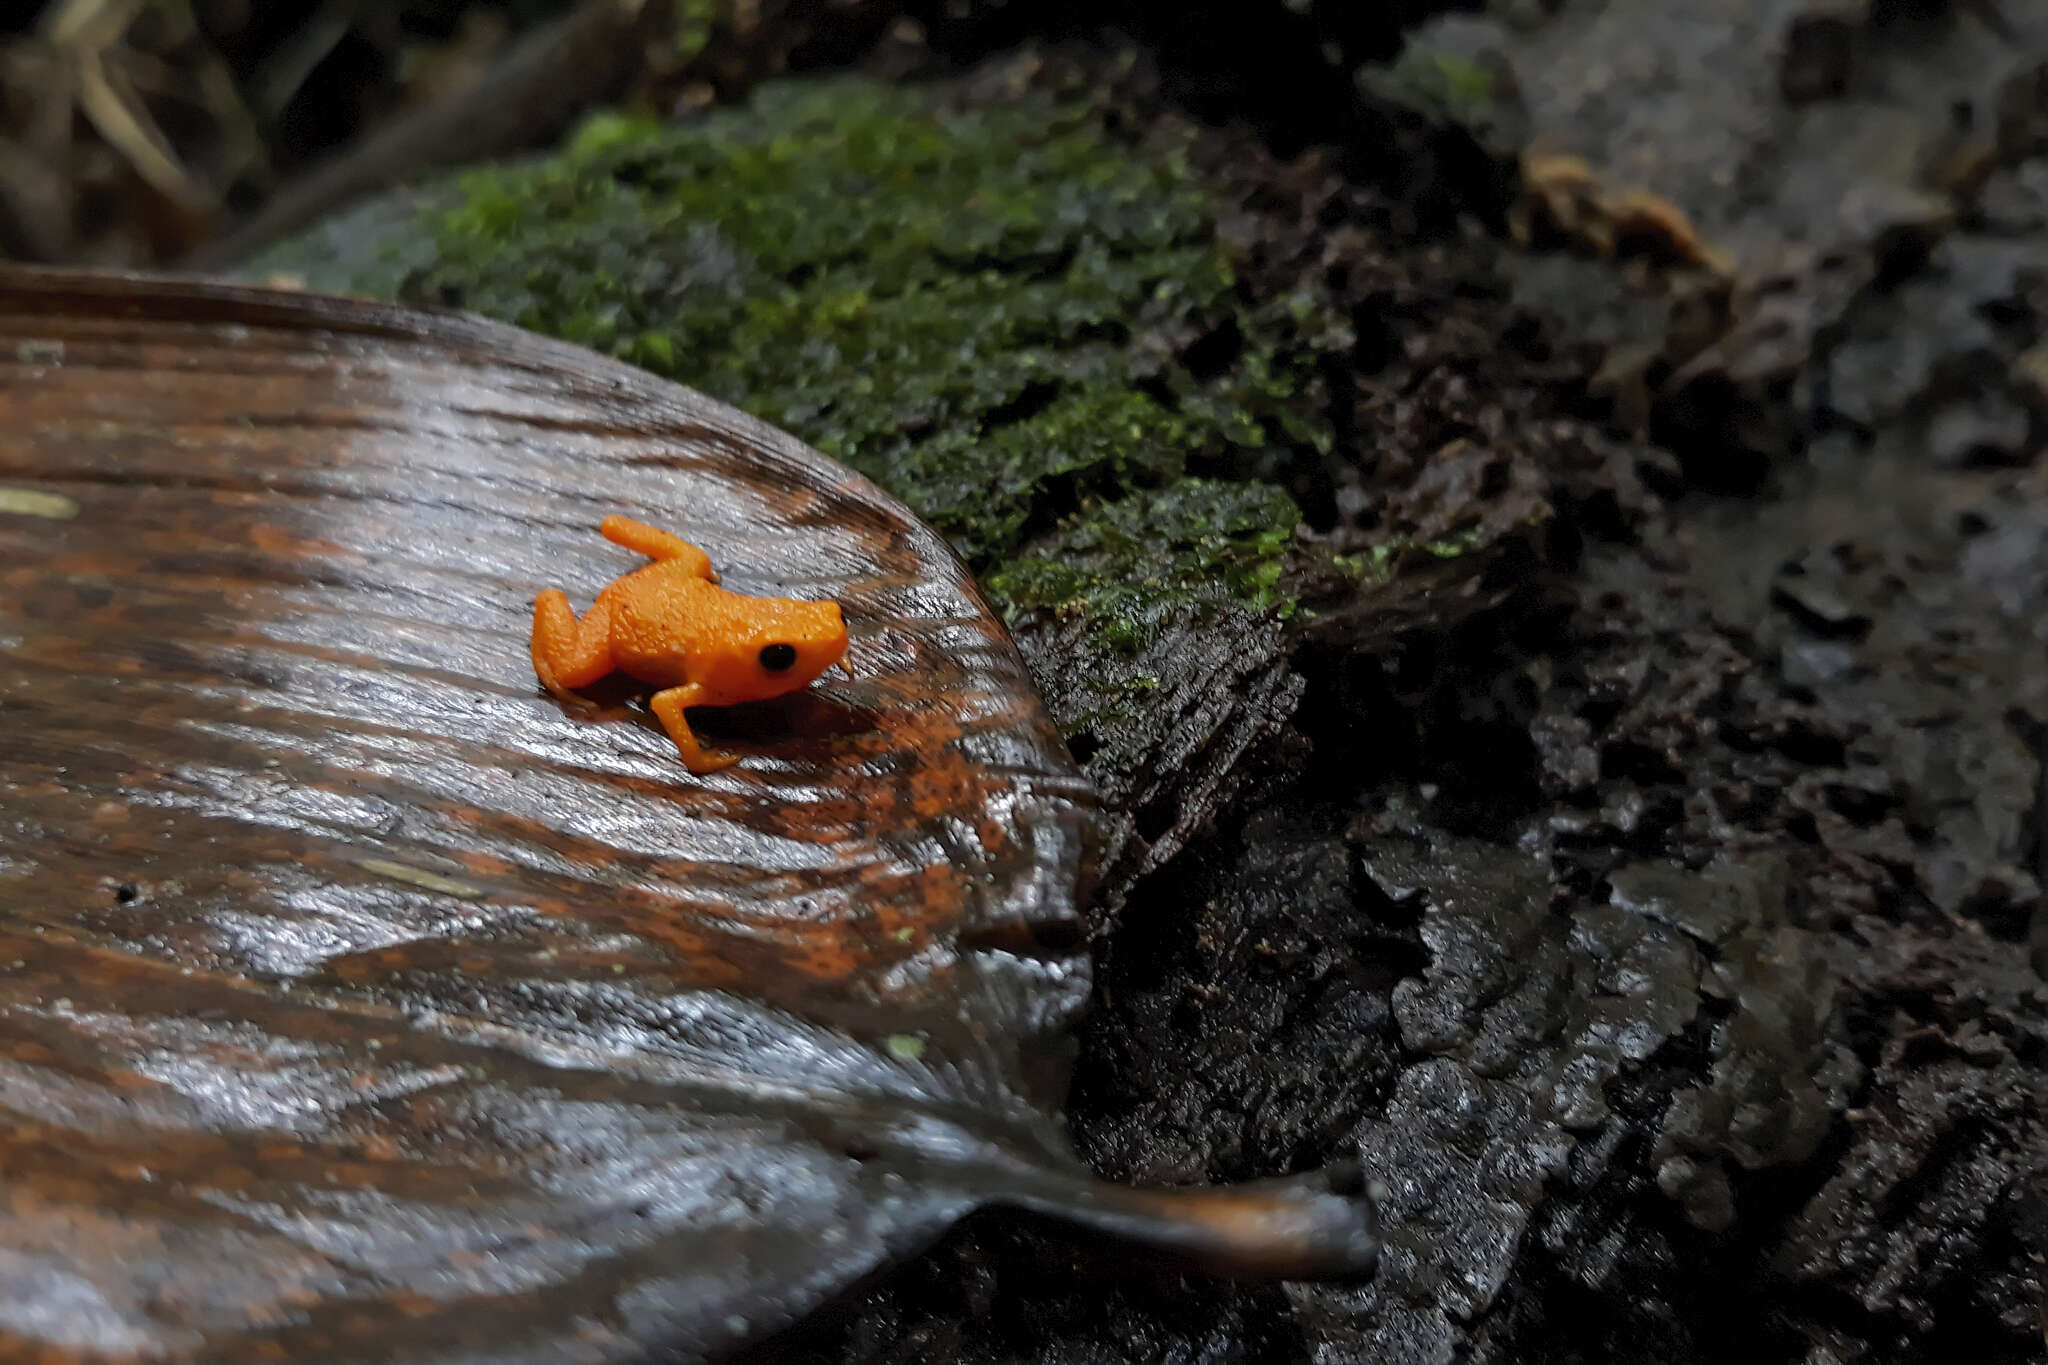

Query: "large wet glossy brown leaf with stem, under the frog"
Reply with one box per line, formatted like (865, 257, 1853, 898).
(0, 272, 1374, 1361)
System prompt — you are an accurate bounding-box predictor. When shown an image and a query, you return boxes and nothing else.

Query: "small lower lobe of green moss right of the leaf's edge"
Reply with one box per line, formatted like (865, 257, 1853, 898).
(989, 479, 1300, 655)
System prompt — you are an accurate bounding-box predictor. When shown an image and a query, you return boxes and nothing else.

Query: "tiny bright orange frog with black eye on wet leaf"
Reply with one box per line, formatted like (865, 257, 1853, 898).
(532, 516, 852, 774)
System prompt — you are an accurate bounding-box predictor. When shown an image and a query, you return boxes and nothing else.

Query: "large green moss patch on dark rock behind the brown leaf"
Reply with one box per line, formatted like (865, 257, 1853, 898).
(258, 78, 1376, 703)
